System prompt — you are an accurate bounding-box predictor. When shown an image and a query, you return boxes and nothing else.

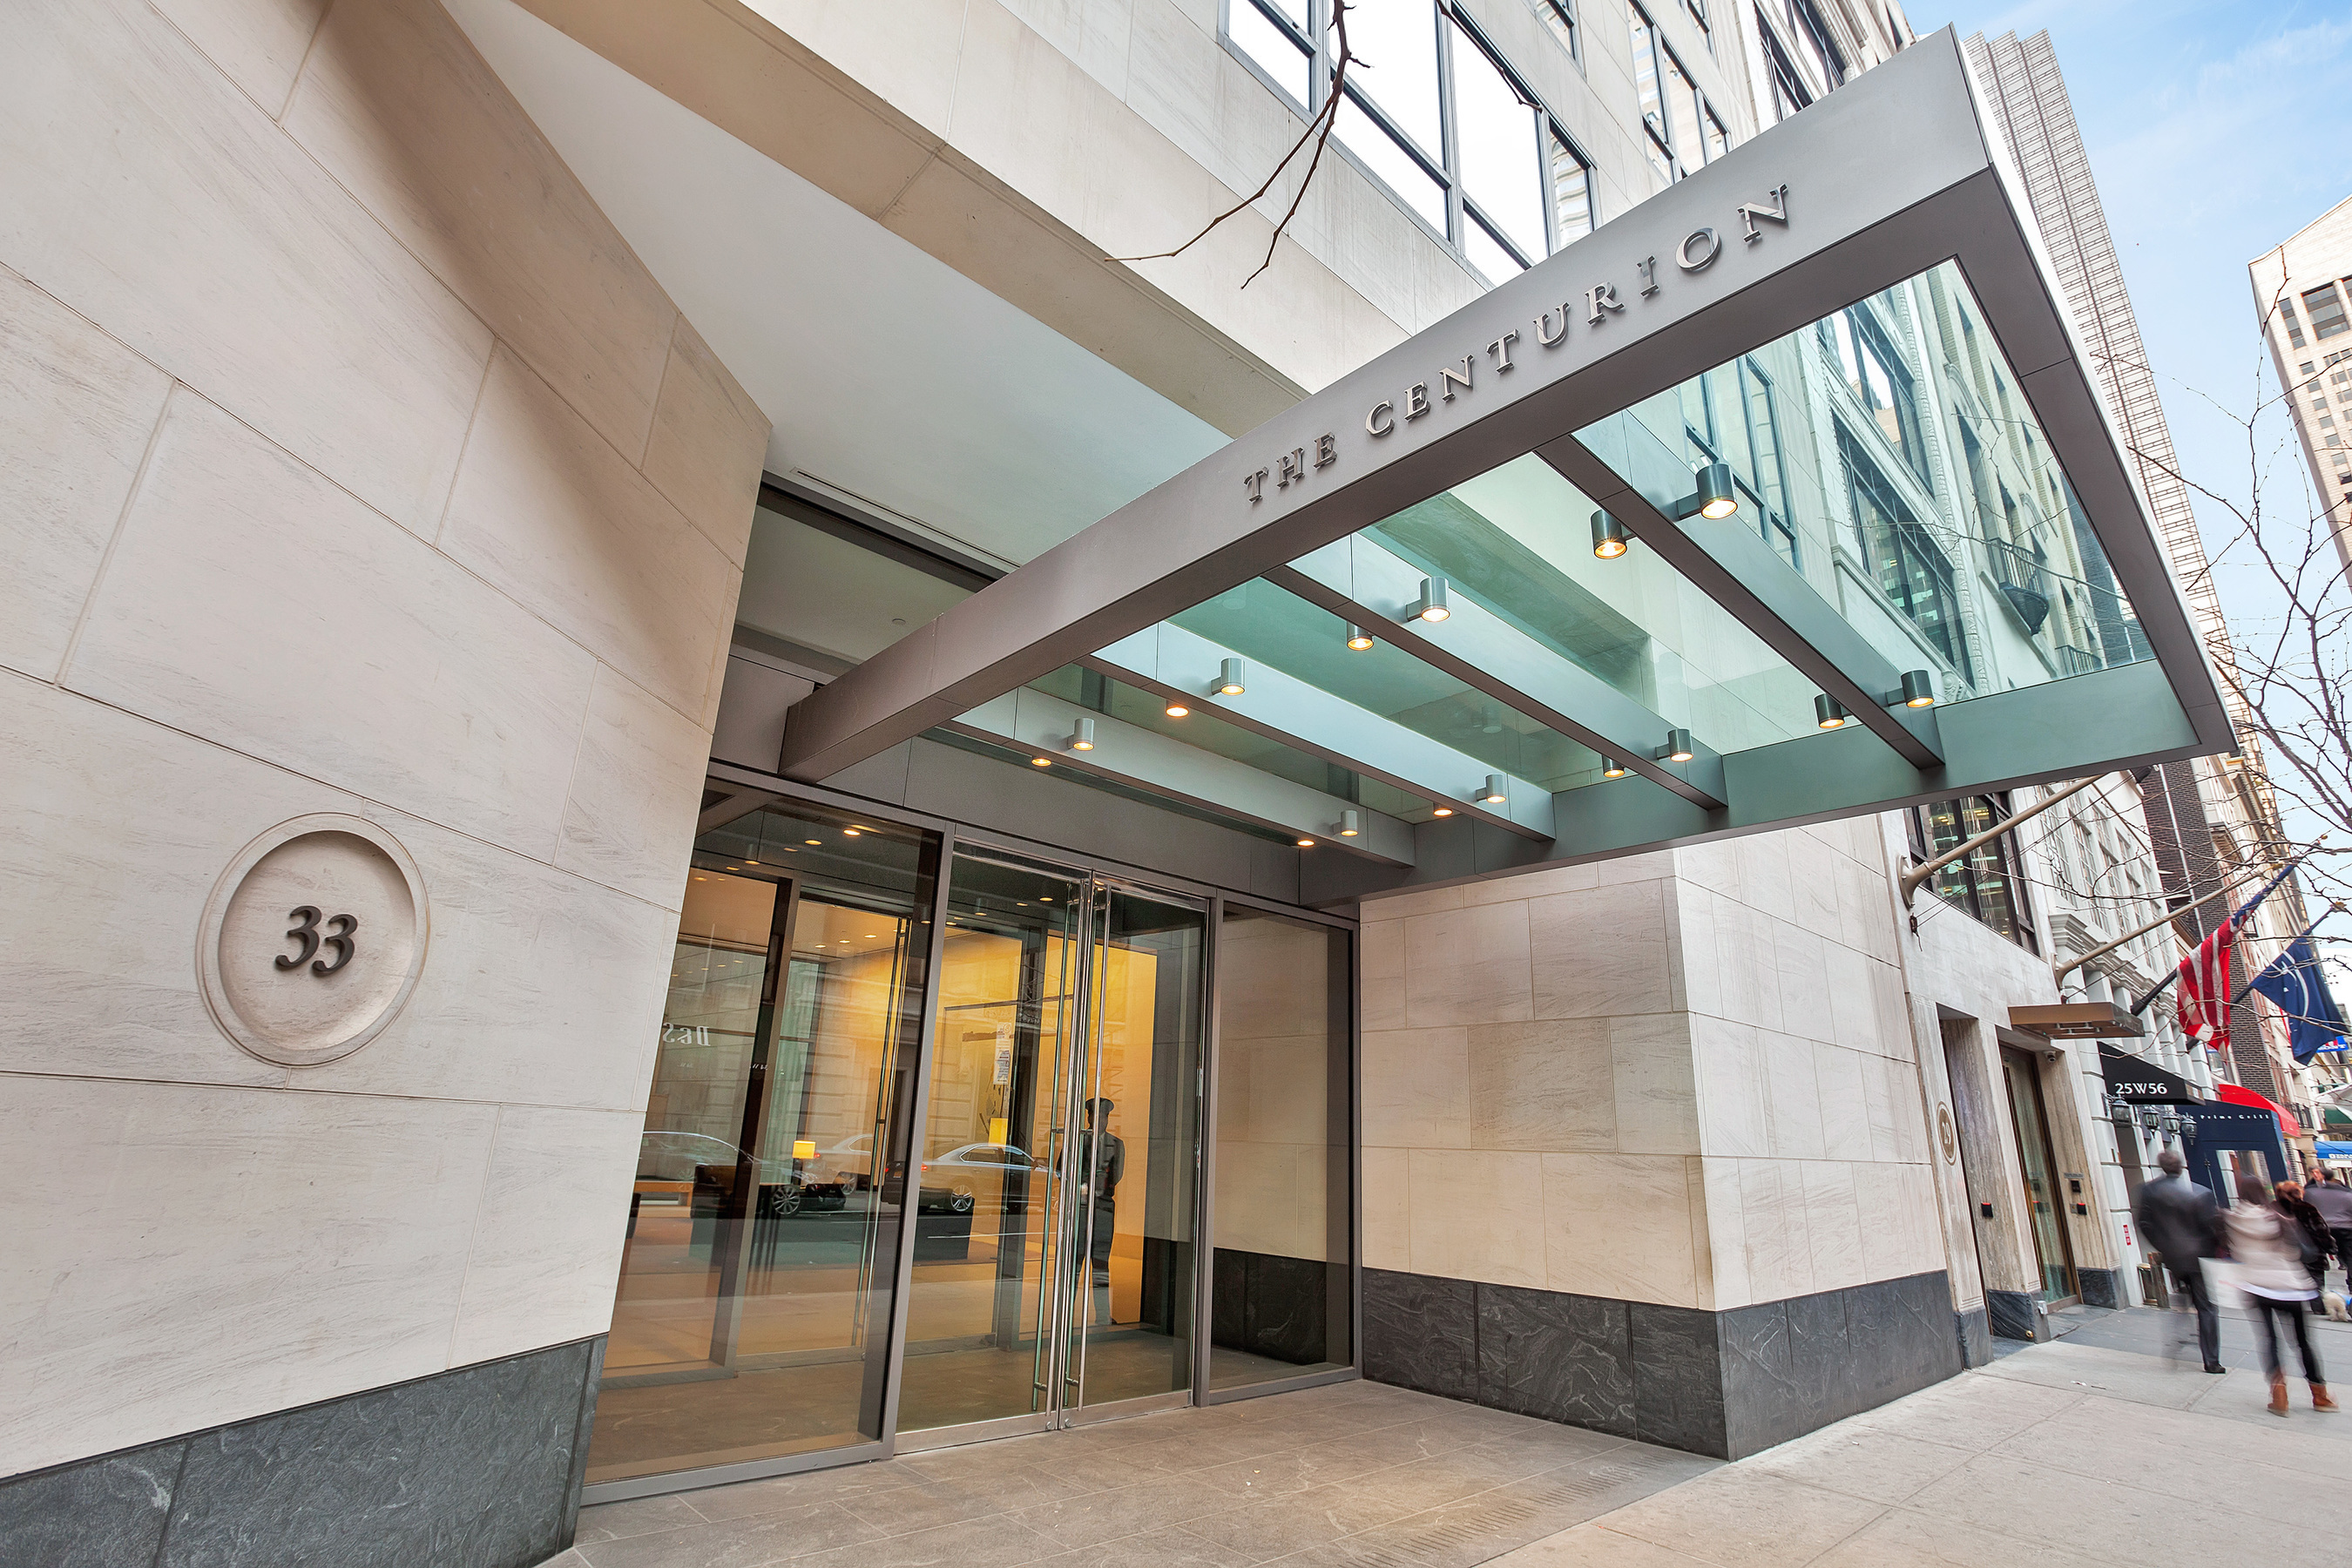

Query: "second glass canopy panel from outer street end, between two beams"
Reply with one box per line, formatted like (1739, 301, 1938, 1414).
(1360, 456, 1815, 756)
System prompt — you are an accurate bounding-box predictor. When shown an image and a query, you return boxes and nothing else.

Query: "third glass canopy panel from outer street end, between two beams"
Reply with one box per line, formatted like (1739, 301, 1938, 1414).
(1169, 578, 1602, 789)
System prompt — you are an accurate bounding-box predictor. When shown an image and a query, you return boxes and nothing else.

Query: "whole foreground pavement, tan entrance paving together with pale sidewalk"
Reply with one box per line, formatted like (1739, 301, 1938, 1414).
(551, 1309, 2352, 1568)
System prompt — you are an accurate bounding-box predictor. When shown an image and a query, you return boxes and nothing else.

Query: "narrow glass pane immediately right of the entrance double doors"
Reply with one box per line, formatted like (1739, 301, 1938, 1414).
(1209, 905, 1355, 1389)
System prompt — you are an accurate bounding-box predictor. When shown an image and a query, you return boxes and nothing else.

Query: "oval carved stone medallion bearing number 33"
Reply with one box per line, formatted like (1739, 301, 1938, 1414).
(195, 814, 428, 1067)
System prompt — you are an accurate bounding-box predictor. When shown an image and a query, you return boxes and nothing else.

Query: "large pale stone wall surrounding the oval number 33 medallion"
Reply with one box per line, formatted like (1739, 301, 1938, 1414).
(0, 0, 767, 1474)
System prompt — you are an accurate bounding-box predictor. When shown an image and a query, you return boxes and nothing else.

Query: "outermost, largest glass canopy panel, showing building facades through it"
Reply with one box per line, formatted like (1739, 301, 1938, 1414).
(1578, 263, 2153, 703)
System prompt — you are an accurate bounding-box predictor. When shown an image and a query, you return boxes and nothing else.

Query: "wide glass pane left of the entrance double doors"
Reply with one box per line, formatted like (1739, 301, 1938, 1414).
(588, 807, 936, 1484)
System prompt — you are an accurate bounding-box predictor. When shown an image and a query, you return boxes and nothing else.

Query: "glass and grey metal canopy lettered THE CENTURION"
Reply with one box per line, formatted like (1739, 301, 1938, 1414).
(783, 33, 2232, 896)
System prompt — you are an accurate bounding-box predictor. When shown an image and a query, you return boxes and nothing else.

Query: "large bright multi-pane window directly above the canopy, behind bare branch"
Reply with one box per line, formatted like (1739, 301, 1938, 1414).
(1226, 0, 1597, 282)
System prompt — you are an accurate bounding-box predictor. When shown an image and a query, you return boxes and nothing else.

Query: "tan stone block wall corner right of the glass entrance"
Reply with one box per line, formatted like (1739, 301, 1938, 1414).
(1362, 821, 1945, 1309)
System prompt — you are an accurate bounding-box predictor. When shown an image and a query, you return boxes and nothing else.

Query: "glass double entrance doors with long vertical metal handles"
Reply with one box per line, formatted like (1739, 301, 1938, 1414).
(894, 854, 1206, 1434)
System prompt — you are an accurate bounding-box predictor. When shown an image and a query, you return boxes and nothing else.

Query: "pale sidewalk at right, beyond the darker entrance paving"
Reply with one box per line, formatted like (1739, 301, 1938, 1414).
(1491, 1309, 2352, 1568)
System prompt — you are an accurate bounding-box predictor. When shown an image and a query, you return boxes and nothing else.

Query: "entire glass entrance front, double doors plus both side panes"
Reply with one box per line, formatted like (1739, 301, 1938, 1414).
(588, 801, 1353, 1497)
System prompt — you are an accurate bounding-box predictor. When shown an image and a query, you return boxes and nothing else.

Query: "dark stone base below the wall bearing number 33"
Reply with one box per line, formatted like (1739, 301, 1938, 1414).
(0, 1335, 605, 1568)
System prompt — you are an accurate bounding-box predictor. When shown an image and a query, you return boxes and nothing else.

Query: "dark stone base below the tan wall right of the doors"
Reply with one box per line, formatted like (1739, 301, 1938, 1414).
(1364, 1269, 1962, 1460)
